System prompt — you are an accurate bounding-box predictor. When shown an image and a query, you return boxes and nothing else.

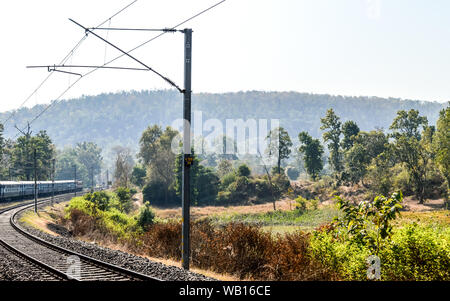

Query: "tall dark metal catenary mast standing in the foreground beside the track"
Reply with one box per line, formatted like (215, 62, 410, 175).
(181, 29, 192, 270)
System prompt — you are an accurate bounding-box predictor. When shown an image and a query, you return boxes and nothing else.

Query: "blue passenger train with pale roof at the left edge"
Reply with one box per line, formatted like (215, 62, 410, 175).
(0, 180, 83, 202)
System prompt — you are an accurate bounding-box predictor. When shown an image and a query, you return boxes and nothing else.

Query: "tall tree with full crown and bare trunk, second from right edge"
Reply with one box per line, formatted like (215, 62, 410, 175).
(390, 110, 430, 204)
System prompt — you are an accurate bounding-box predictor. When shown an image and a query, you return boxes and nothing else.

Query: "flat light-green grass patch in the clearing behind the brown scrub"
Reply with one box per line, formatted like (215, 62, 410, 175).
(210, 206, 339, 233)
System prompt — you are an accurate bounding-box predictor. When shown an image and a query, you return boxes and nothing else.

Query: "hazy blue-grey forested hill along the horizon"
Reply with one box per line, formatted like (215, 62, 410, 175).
(0, 90, 448, 150)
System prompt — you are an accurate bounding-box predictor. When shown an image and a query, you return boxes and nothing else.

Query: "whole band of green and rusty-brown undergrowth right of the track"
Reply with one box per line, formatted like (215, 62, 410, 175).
(58, 188, 450, 281)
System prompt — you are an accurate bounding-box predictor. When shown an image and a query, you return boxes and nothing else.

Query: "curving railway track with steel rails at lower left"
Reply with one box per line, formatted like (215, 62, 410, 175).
(0, 194, 161, 281)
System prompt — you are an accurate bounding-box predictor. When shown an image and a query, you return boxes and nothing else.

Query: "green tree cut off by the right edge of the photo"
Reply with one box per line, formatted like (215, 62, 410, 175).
(433, 107, 450, 199)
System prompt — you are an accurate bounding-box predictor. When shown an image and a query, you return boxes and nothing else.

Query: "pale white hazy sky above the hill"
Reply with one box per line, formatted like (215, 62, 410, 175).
(0, 0, 450, 112)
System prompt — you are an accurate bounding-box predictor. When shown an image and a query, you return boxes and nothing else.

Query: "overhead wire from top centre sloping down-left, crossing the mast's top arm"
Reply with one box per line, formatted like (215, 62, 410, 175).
(16, 0, 226, 137)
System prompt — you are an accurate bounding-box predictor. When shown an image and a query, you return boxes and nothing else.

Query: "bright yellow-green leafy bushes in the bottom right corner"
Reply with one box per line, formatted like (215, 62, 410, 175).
(311, 224, 450, 281)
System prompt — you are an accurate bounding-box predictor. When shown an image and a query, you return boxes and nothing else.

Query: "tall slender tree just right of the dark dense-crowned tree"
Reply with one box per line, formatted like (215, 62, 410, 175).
(320, 109, 343, 175)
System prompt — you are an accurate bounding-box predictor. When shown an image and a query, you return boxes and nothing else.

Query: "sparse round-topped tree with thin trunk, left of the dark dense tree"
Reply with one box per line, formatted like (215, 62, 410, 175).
(266, 127, 292, 174)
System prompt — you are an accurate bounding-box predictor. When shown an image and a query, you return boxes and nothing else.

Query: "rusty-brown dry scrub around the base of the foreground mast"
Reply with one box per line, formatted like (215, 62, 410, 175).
(143, 221, 336, 281)
